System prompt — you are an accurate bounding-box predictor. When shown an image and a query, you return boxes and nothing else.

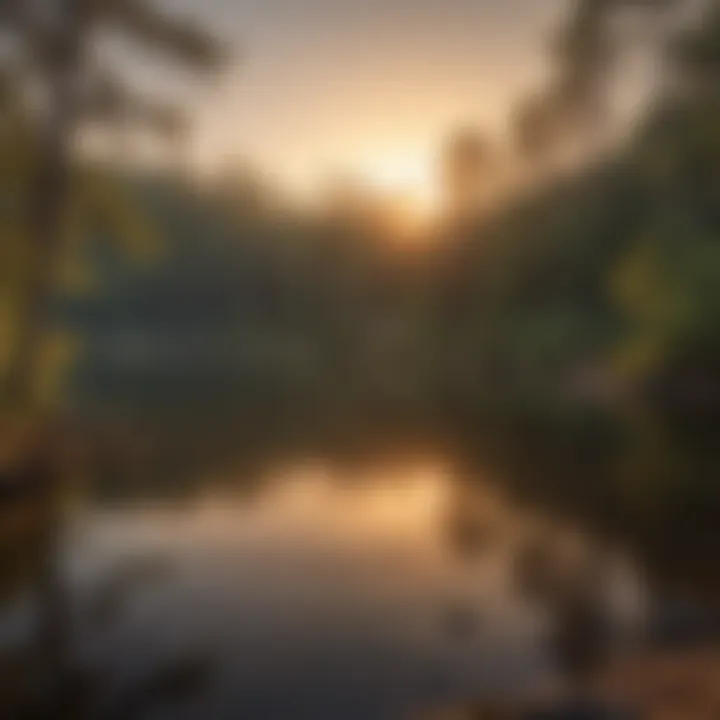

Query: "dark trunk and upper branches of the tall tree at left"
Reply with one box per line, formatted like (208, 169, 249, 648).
(0, 0, 223, 414)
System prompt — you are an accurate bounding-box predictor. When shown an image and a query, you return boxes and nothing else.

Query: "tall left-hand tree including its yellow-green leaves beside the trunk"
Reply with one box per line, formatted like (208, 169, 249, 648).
(0, 0, 223, 414)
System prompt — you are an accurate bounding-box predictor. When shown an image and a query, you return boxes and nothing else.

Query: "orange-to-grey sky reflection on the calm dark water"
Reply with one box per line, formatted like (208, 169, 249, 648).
(0, 459, 645, 720)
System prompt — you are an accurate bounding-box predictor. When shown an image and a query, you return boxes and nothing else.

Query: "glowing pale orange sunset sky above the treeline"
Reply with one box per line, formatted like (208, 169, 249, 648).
(149, 0, 567, 193)
